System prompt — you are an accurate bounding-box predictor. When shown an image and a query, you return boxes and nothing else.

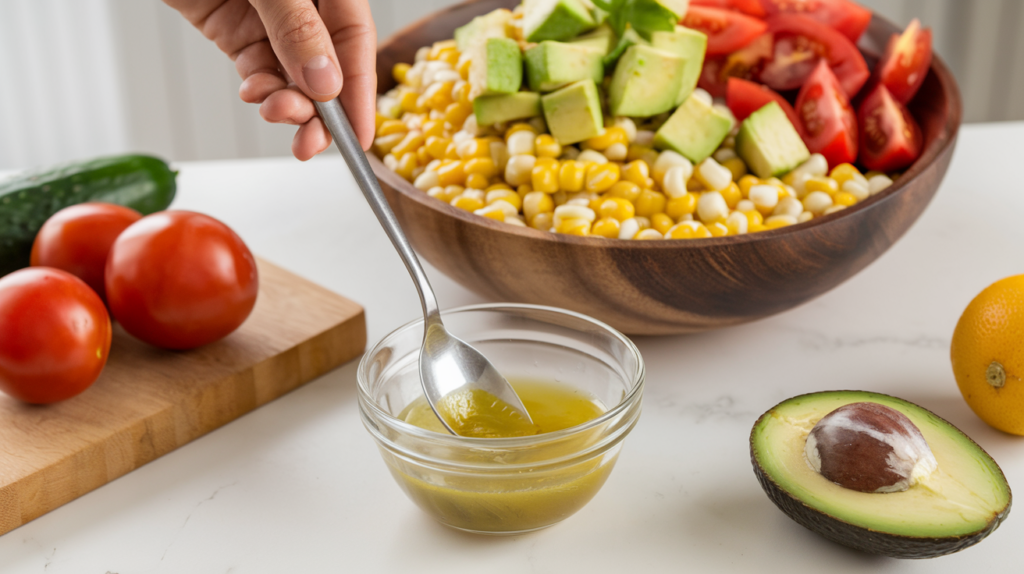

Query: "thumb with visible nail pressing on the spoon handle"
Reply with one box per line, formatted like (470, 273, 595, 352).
(251, 0, 342, 101)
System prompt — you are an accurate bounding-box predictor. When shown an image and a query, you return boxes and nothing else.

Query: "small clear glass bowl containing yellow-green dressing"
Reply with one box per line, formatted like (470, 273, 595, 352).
(358, 303, 644, 534)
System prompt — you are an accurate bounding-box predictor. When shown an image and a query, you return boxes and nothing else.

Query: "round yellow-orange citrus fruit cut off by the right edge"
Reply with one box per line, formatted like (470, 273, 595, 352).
(949, 275, 1024, 435)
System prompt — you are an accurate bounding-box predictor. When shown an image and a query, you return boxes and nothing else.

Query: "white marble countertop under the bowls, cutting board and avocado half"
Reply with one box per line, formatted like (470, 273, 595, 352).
(0, 123, 1024, 574)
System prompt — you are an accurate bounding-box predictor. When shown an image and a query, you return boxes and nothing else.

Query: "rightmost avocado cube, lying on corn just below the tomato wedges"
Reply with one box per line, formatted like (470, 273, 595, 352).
(736, 101, 811, 178)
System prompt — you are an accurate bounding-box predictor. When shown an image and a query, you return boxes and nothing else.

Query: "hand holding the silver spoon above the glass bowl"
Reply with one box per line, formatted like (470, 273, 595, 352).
(164, 0, 377, 161)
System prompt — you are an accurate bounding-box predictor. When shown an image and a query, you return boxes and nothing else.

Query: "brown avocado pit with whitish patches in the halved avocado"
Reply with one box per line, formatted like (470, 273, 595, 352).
(804, 402, 938, 492)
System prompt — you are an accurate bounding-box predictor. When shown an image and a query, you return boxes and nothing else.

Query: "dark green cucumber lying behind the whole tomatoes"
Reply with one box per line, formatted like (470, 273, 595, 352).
(0, 156, 177, 276)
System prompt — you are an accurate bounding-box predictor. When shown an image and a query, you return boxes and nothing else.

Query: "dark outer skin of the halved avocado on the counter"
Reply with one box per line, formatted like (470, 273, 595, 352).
(751, 391, 1013, 559)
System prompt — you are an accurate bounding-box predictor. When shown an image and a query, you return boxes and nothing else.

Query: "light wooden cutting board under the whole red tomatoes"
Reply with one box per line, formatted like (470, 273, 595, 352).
(0, 260, 367, 534)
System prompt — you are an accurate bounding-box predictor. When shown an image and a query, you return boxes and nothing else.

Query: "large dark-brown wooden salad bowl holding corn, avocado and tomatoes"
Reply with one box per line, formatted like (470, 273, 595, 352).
(370, 0, 963, 335)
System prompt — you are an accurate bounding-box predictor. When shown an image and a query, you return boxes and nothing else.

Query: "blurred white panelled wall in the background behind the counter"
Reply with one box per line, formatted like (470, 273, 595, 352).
(0, 0, 1024, 169)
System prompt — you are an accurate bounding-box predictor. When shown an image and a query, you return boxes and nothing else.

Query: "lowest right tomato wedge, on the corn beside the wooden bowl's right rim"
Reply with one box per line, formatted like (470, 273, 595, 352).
(857, 84, 924, 172)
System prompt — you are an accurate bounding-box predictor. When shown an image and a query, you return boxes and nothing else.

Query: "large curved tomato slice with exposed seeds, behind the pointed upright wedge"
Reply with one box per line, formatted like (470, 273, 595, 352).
(759, 14, 870, 98)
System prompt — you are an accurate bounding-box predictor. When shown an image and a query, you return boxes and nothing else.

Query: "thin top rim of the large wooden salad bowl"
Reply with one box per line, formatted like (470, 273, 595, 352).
(367, 0, 964, 250)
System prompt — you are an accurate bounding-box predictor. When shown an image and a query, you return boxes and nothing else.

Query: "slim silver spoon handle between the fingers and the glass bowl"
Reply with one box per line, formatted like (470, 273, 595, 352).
(313, 98, 440, 326)
